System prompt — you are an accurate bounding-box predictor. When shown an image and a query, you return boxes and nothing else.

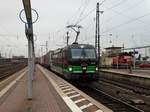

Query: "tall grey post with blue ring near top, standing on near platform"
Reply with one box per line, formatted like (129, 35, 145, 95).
(19, 0, 38, 100)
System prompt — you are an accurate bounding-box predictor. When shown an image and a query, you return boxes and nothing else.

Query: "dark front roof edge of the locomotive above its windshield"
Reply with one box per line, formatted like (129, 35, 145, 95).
(64, 44, 94, 49)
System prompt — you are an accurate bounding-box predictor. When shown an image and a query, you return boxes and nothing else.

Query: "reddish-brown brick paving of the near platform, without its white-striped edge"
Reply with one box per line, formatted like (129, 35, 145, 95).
(0, 66, 70, 112)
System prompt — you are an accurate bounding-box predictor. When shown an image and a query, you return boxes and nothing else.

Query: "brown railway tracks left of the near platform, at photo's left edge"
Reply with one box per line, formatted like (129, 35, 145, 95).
(0, 64, 26, 80)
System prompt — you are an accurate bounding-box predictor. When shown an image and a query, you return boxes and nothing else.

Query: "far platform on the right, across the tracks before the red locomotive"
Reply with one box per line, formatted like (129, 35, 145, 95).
(100, 69, 150, 88)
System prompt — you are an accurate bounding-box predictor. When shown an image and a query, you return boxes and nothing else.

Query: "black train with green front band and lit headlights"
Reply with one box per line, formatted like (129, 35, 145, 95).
(39, 44, 98, 81)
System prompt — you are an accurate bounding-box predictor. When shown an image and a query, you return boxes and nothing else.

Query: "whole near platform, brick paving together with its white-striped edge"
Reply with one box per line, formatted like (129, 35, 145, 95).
(0, 65, 112, 112)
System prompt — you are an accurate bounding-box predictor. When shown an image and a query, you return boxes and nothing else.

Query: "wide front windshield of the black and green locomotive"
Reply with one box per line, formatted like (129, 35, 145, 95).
(71, 48, 96, 59)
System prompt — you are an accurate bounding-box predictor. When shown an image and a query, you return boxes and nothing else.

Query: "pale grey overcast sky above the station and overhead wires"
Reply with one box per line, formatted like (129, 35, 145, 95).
(0, 0, 150, 56)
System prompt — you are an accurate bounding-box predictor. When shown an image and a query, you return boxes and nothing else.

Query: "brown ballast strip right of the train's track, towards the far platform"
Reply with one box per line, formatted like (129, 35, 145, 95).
(92, 81, 150, 112)
